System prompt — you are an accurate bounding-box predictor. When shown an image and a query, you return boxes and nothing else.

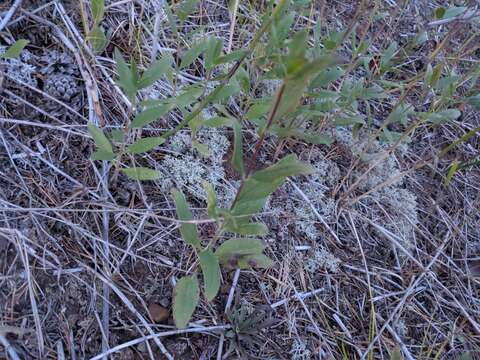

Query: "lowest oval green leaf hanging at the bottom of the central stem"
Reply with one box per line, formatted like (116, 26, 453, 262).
(173, 274, 200, 329)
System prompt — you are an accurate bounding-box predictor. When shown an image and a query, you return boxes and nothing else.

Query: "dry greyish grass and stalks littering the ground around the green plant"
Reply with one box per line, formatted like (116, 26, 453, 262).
(0, 0, 480, 359)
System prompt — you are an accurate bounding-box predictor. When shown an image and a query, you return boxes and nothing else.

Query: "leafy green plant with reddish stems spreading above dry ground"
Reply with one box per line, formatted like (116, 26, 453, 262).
(89, 0, 478, 327)
